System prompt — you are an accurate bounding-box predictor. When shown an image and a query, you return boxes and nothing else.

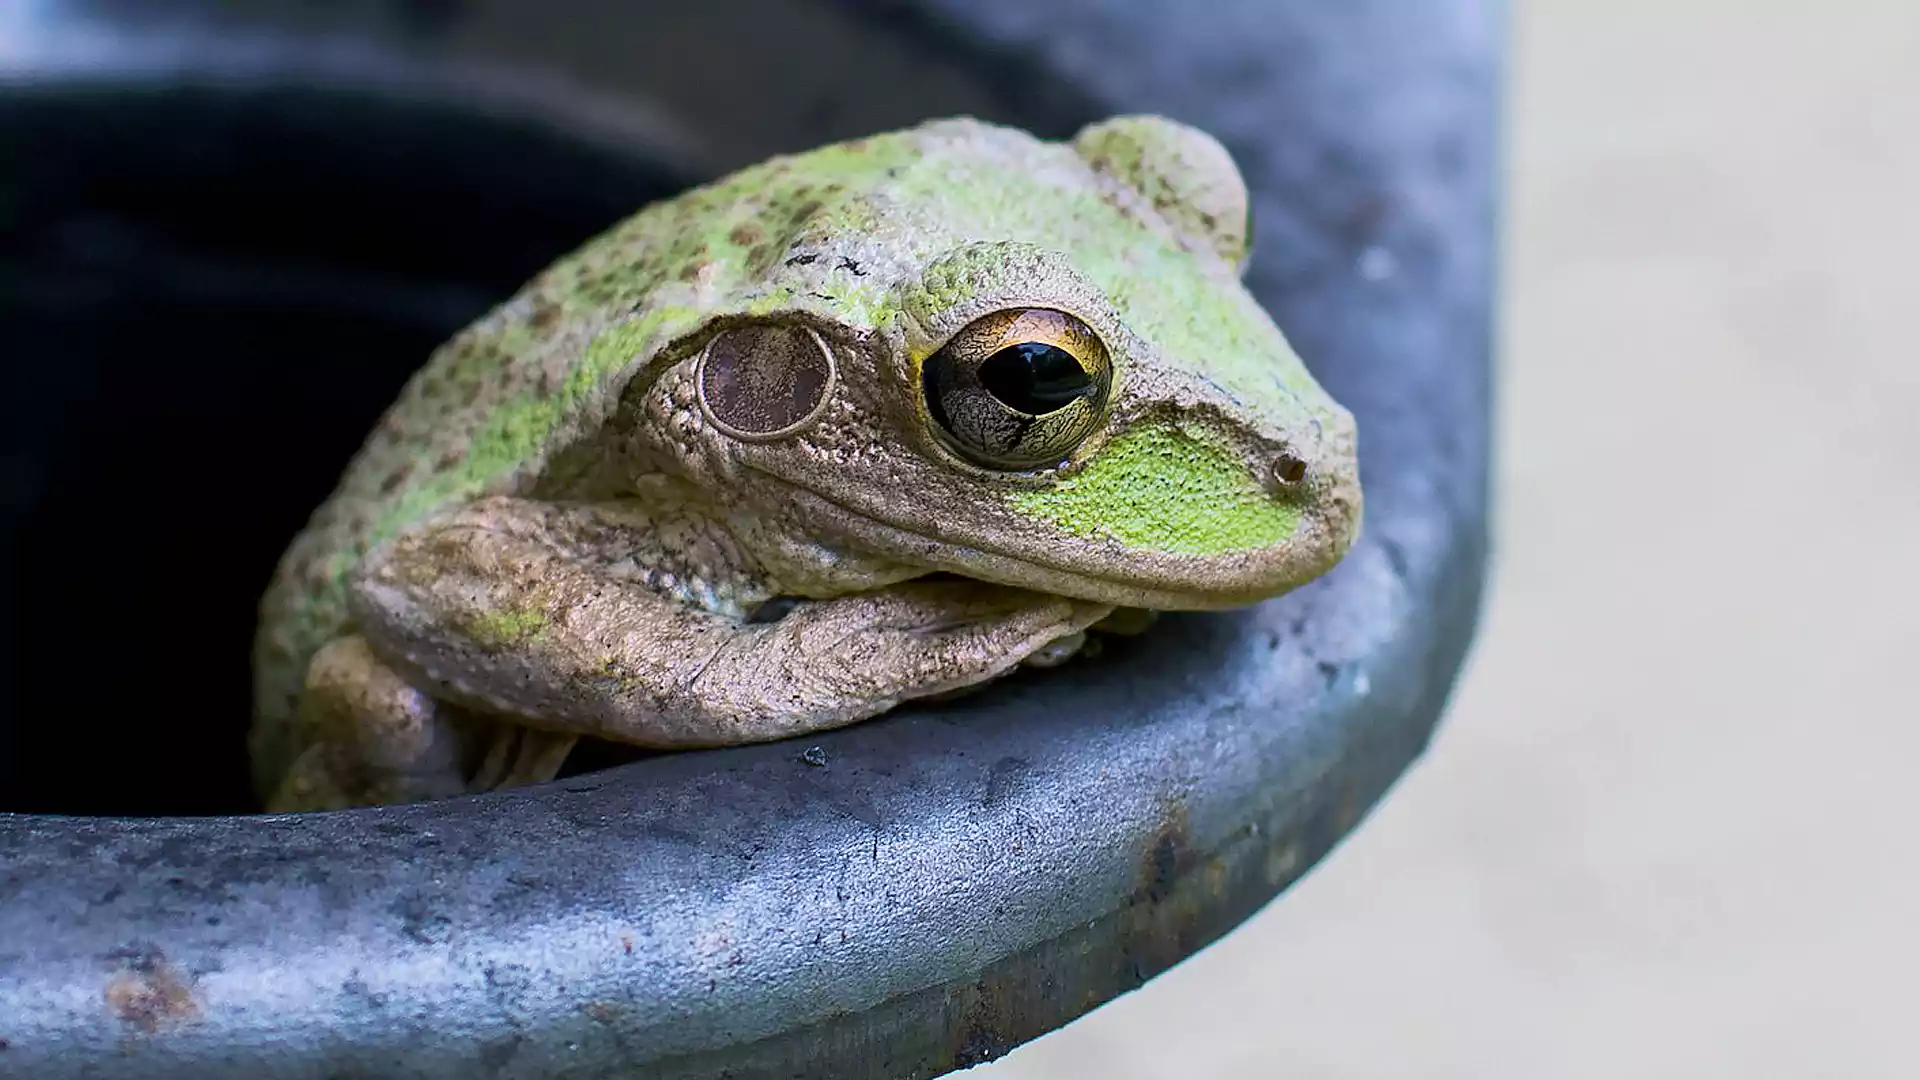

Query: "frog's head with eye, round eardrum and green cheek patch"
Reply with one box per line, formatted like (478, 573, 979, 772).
(652, 117, 1361, 609)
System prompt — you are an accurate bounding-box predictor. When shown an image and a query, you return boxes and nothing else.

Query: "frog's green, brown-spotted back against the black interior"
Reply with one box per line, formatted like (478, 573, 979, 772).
(253, 131, 936, 784)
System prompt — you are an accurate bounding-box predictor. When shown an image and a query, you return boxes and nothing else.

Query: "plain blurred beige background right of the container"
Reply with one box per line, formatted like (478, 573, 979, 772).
(970, 0, 1920, 1080)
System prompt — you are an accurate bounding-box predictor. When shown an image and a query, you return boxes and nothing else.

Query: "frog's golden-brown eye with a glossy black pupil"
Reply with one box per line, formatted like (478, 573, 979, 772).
(920, 307, 1114, 469)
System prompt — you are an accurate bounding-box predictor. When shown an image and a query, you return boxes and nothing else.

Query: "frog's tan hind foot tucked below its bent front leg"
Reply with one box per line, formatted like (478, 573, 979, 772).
(267, 636, 574, 813)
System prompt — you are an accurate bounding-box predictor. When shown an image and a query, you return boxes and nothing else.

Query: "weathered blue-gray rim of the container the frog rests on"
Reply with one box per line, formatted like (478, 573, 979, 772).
(0, 0, 1503, 1080)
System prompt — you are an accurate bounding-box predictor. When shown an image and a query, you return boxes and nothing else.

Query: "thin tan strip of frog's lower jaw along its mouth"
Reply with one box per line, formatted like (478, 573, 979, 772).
(768, 488, 1325, 611)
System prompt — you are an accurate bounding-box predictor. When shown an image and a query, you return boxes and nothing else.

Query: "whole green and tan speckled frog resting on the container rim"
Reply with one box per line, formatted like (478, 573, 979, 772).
(250, 113, 1361, 813)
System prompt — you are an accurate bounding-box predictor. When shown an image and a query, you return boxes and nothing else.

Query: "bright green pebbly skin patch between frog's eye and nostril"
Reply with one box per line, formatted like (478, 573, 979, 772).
(1008, 425, 1300, 555)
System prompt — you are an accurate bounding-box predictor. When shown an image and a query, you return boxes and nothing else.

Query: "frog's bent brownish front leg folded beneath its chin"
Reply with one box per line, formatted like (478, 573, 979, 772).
(355, 498, 1112, 748)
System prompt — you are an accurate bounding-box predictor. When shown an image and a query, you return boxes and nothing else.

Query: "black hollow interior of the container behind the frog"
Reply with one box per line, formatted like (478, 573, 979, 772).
(0, 86, 684, 815)
